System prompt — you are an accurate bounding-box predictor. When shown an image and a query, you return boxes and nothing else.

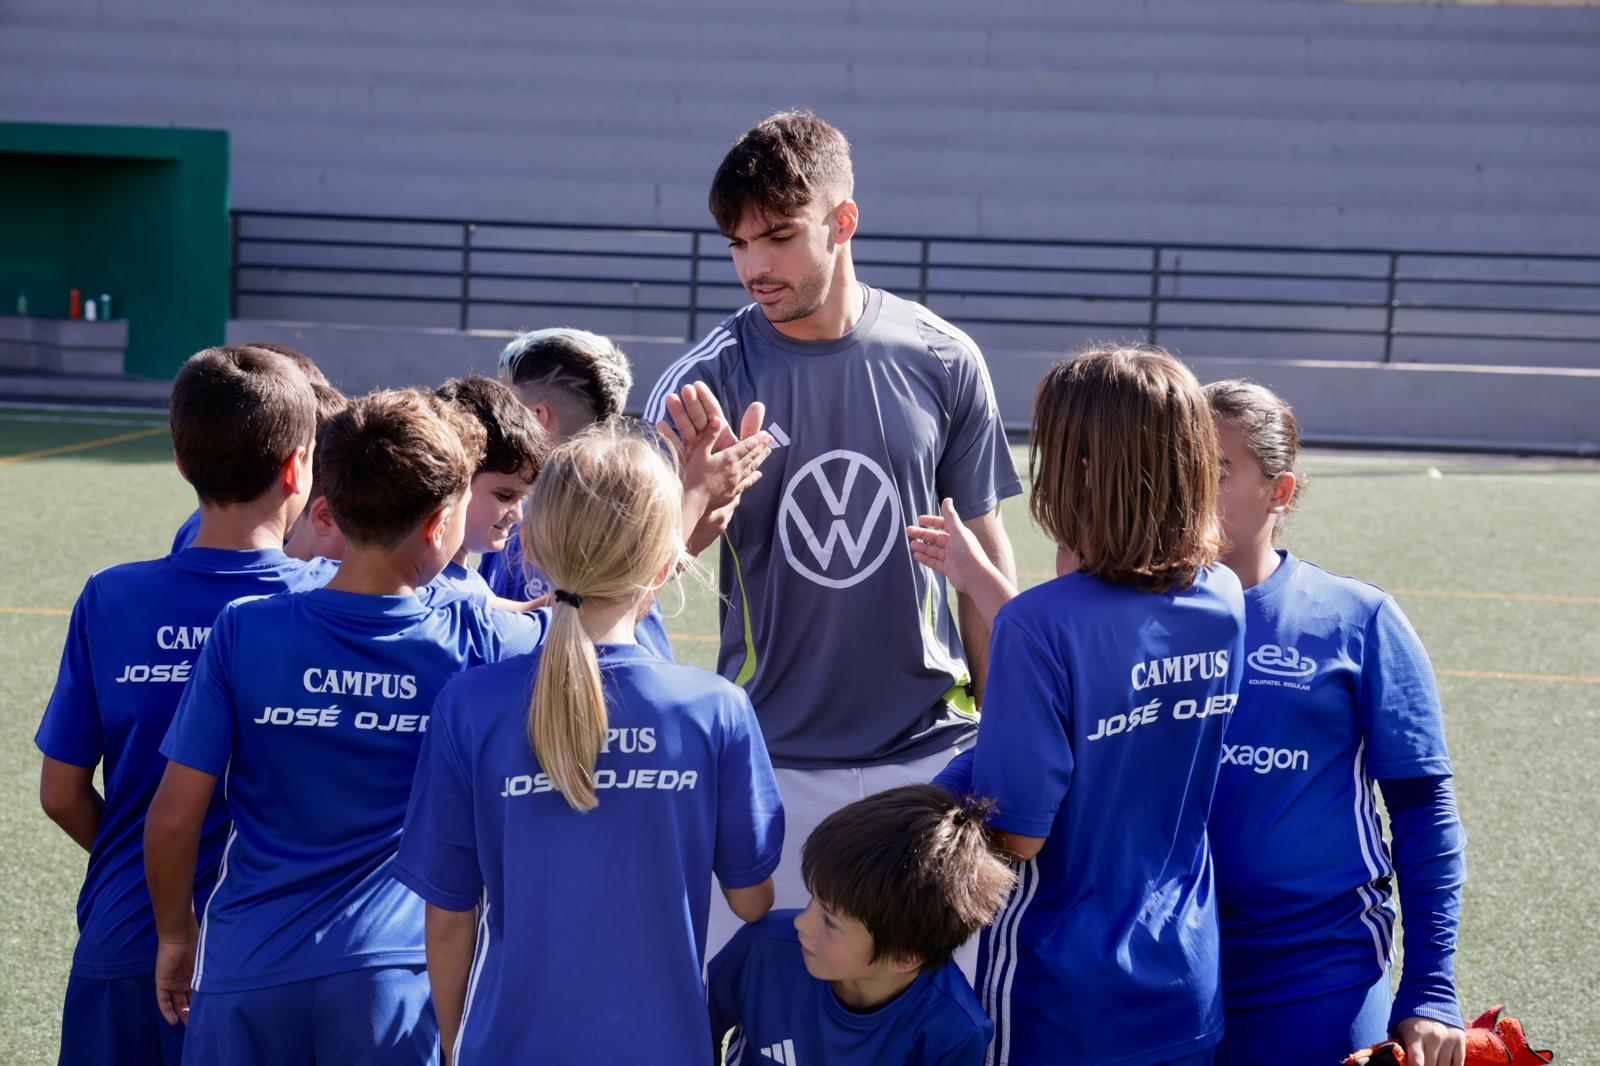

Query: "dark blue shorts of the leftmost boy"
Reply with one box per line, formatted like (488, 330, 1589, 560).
(61, 973, 184, 1066)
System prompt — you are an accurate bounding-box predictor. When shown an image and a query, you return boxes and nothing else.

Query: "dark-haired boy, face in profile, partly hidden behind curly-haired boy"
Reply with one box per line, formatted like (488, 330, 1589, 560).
(424, 375, 550, 603)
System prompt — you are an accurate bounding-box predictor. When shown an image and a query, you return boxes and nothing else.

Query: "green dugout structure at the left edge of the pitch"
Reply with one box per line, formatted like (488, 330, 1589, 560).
(0, 123, 229, 378)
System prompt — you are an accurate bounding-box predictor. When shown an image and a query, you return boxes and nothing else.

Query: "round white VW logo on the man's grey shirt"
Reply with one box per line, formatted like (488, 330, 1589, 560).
(778, 450, 901, 589)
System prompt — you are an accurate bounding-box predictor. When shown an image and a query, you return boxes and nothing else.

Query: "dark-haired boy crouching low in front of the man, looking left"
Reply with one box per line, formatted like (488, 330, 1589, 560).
(707, 784, 1016, 1066)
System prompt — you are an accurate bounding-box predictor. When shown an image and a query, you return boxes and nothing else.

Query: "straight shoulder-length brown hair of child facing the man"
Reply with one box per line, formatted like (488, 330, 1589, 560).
(1029, 346, 1222, 592)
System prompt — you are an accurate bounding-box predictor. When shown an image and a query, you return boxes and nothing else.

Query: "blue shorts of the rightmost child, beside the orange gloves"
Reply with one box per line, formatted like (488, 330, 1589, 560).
(1216, 972, 1394, 1066)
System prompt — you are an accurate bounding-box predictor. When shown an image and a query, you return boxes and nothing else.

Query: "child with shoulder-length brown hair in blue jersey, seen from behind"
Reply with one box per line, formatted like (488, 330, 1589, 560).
(910, 347, 1245, 1066)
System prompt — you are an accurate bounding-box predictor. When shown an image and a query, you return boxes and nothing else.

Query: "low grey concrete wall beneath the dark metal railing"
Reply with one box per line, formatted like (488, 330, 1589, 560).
(227, 313, 1600, 456)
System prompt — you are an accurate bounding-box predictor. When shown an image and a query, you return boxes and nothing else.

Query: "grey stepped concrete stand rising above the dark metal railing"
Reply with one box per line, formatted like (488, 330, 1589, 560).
(0, 0, 1600, 251)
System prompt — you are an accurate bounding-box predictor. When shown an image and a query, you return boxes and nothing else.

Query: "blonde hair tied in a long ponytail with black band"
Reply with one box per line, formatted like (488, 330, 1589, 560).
(522, 423, 683, 812)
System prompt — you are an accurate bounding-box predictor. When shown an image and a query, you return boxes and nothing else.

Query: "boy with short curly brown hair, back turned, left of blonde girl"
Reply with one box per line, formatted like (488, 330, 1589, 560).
(146, 391, 542, 1066)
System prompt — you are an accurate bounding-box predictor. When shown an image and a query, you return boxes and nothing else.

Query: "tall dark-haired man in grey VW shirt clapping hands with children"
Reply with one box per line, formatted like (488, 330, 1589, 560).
(645, 112, 1021, 934)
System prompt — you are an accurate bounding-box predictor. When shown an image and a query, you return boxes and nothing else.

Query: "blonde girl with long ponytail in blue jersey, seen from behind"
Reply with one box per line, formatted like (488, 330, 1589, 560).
(395, 424, 782, 1064)
